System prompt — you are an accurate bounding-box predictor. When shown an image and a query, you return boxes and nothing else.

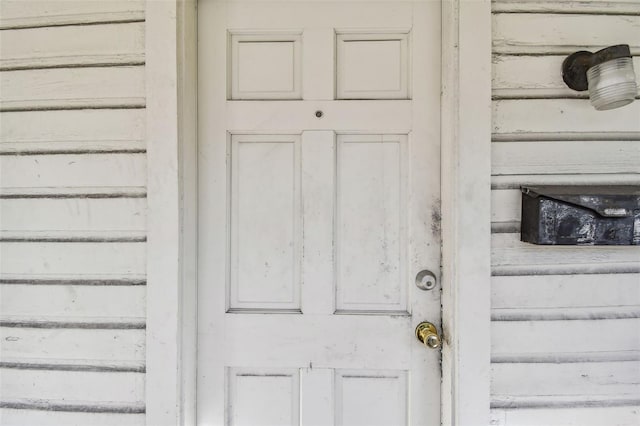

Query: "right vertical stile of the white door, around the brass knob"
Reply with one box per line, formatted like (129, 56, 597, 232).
(407, 2, 441, 425)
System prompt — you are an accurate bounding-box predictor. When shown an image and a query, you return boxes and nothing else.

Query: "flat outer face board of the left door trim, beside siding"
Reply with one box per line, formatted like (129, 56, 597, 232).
(144, 0, 182, 426)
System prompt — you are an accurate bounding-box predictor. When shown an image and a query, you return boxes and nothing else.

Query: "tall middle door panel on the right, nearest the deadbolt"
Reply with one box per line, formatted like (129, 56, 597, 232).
(336, 135, 407, 312)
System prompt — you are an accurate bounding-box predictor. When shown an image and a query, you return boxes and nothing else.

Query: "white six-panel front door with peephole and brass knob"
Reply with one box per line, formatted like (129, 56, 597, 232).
(198, 0, 440, 426)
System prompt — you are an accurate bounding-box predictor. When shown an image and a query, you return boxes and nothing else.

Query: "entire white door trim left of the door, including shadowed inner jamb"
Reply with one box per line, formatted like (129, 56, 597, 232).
(145, 0, 198, 426)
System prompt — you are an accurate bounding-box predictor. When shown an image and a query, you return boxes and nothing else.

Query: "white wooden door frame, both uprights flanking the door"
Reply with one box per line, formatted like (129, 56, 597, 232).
(145, 0, 491, 426)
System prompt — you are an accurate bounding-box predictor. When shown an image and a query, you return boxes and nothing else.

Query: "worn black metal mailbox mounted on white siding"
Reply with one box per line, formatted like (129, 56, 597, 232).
(521, 186, 640, 245)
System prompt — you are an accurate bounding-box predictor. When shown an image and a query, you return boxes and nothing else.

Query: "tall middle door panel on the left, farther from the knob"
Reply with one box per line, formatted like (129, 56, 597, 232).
(229, 135, 301, 311)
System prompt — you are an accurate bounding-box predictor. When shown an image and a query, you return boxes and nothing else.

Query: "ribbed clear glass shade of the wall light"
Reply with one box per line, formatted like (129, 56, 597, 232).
(587, 57, 638, 111)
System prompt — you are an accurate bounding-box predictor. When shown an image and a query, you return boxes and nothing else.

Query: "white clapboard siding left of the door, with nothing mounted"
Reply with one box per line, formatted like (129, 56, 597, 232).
(0, 0, 146, 426)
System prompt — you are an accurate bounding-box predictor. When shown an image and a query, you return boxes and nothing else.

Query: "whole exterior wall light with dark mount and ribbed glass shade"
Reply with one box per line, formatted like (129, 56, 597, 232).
(562, 44, 638, 111)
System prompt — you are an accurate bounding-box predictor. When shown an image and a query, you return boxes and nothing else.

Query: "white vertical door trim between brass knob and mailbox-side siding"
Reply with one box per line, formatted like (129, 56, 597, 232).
(442, 0, 491, 426)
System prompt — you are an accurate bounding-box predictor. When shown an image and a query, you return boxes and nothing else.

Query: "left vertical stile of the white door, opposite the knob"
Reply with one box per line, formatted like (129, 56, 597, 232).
(196, 1, 231, 424)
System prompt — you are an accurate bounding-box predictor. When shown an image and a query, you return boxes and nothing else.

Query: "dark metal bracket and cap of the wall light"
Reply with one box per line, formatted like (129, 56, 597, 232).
(562, 44, 631, 92)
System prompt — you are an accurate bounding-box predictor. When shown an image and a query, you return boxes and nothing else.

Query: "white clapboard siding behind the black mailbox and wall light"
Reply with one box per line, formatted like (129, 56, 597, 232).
(491, 0, 640, 426)
